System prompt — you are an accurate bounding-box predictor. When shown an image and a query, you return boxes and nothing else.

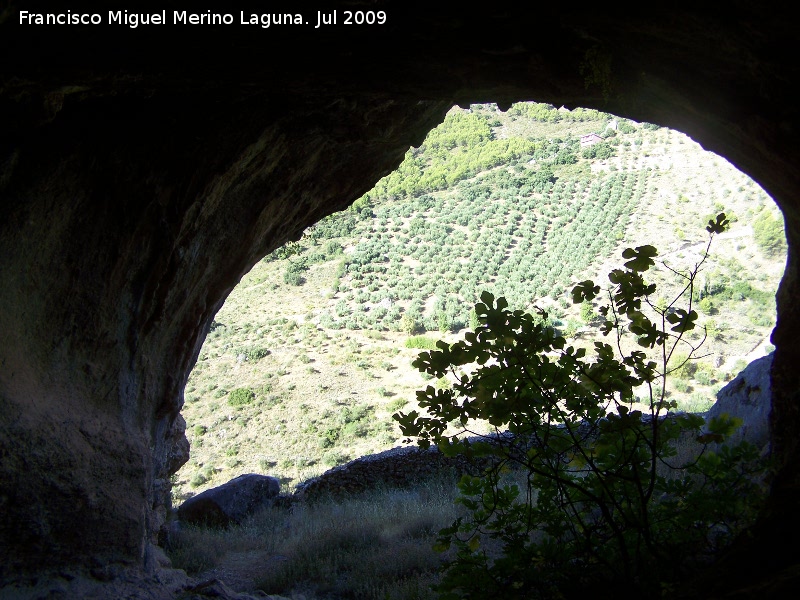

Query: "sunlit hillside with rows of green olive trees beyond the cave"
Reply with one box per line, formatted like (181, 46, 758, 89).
(174, 104, 785, 499)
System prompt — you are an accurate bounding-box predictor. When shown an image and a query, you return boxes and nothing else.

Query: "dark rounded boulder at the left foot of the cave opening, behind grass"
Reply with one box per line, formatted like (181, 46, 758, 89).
(178, 473, 281, 527)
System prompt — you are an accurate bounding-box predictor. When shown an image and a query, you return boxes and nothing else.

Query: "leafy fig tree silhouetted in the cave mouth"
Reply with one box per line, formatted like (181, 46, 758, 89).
(395, 214, 763, 600)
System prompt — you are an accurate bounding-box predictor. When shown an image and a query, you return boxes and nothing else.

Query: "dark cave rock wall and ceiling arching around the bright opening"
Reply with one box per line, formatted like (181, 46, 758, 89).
(0, 0, 800, 592)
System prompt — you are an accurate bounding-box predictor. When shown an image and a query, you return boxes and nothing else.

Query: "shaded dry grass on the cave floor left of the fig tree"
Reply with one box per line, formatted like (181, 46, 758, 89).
(170, 481, 457, 600)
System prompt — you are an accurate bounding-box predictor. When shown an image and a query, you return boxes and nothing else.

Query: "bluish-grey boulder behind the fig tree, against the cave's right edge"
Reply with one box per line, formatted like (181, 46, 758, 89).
(706, 354, 773, 449)
